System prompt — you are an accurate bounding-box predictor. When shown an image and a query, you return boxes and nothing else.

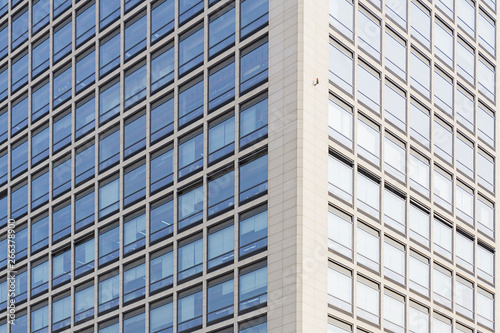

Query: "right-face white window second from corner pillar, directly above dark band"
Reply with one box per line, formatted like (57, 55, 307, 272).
(356, 115, 380, 165)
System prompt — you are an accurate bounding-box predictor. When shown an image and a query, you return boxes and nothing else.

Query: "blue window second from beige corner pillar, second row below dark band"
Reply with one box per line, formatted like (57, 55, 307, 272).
(207, 224, 234, 269)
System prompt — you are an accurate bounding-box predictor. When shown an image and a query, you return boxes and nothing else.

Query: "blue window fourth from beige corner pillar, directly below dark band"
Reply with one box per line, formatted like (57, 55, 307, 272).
(149, 200, 174, 243)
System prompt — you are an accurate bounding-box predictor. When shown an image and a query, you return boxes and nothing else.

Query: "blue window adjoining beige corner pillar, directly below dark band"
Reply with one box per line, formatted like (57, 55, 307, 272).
(240, 155, 267, 202)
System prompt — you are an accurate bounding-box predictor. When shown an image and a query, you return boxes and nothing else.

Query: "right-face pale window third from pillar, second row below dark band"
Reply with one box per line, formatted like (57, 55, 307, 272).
(384, 237, 406, 286)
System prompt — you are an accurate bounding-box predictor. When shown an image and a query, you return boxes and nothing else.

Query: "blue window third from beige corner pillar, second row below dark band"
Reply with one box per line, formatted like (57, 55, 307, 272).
(177, 238, 203, 281)
